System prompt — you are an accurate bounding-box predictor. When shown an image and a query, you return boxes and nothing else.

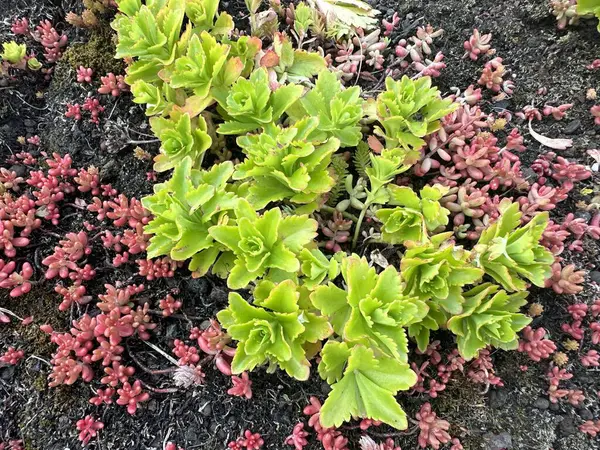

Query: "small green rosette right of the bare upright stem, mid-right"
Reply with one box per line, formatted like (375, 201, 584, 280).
(376, 184, 450, 244)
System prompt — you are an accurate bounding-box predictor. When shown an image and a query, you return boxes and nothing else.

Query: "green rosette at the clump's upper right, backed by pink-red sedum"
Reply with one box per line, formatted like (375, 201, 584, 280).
(372, 75, 458, 150)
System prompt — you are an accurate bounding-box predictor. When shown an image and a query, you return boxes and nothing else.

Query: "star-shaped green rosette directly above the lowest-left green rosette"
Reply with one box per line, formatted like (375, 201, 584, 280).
(209, 199, 317, 289)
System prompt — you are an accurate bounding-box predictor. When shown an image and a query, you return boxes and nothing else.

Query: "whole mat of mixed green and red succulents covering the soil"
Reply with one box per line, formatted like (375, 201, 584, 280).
(0, 0, 600, 450)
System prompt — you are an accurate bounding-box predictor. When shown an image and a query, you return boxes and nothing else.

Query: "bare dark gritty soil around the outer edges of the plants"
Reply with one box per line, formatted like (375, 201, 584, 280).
(0, 0, 600, 450)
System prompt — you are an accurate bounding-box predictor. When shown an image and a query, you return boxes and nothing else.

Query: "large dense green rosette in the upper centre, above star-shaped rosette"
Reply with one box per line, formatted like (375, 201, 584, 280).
(233, 116, 340, 209)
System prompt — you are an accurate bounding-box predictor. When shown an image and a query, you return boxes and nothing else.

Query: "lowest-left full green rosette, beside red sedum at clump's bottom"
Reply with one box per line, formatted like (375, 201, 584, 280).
(217, 280, 332, 380)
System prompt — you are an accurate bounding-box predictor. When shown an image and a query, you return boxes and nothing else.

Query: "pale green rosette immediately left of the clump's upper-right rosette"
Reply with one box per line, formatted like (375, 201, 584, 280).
(290, 69, 364, 147)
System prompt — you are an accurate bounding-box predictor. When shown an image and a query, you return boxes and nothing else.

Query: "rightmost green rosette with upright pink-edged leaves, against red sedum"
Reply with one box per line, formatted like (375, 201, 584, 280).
(474, 201, 554, 291)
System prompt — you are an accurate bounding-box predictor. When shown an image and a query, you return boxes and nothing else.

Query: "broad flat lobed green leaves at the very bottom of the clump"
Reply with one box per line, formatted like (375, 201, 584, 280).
(319, 340, 417, 430)
